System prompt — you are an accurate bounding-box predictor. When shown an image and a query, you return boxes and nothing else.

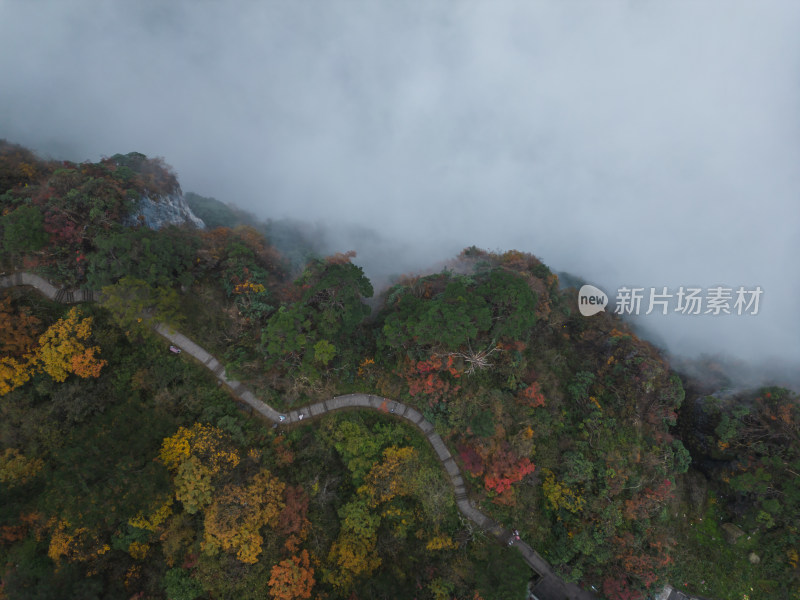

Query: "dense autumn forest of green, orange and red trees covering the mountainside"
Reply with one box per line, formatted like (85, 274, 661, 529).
(0, 142, 800, 600)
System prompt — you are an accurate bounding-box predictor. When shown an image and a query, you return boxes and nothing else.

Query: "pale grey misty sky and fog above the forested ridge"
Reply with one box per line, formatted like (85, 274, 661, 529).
(0, 0, 800, 376)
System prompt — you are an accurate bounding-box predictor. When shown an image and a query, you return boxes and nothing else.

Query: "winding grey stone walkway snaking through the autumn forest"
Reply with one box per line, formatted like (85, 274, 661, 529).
(0, 272, 596, 600)
